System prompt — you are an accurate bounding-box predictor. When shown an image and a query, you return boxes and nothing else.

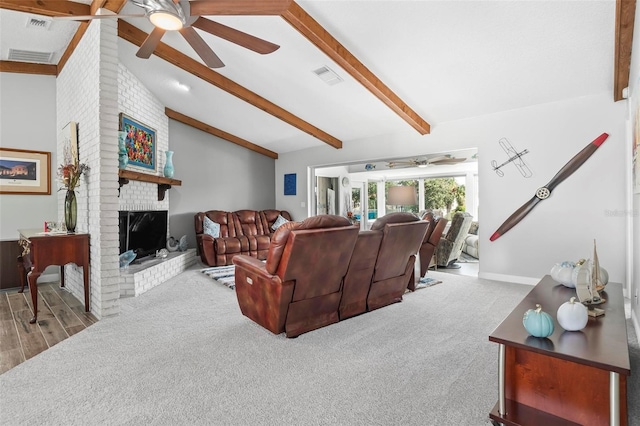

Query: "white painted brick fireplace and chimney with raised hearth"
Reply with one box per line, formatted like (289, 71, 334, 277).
(52, 20, 195, 318)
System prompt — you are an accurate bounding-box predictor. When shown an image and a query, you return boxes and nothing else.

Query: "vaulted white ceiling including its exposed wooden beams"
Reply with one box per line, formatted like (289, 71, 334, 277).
(0, 0, 635, 158)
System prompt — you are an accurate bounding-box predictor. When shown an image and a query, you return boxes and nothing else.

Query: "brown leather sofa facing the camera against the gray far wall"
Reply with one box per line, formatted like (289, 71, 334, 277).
(194, 210, 291, 266)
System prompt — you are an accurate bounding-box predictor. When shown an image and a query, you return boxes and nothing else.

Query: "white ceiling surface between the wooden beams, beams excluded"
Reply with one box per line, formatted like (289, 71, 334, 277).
(0, 0, 615, 153)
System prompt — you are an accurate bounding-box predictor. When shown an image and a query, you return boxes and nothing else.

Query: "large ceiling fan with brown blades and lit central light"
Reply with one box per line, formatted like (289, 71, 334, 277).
(58, 0, 291, 68)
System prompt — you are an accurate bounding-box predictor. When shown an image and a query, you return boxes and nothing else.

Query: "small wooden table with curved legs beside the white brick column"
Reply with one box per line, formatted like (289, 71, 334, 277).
(18, 229, 89, 324)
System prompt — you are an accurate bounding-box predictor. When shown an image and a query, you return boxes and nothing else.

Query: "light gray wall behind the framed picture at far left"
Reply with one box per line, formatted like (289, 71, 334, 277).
(0, 72, 58, 240)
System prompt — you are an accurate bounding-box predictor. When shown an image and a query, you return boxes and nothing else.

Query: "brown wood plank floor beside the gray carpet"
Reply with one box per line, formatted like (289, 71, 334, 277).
(0, 283, 98, 374)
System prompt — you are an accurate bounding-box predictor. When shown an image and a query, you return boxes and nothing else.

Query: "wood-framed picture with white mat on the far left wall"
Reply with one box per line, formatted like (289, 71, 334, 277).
(0, 148, 51, 195)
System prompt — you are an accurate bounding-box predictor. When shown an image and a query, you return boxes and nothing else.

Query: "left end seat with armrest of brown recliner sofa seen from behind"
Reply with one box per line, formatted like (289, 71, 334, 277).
(233, 215, 358, 337)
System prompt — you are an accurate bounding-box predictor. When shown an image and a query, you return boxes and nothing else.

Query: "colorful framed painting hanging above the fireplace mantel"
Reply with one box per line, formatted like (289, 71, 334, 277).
(120, 113, 157, 171)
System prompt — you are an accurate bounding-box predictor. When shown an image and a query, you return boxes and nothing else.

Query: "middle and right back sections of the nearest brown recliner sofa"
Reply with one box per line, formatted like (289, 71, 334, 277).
(340, 212, 429, 319)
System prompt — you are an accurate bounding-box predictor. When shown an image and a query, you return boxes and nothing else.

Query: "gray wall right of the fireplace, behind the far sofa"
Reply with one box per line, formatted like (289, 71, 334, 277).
(169, 120, 275, 247)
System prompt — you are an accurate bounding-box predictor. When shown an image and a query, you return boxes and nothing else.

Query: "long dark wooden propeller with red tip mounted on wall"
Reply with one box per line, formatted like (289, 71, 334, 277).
(489, 133, 609, 241)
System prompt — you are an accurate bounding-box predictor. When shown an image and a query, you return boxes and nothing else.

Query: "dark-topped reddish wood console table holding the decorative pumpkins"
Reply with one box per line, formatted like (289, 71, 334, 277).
(489, 275, 631, 426)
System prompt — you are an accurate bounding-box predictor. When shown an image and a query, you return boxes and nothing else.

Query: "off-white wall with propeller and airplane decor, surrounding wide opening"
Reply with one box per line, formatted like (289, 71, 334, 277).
(276, 92, 629, 284)
